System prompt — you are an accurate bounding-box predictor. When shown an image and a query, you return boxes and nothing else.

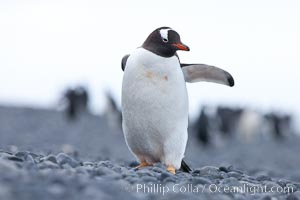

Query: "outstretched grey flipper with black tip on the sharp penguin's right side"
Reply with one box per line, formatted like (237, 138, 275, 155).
(181, 64, 234, 87)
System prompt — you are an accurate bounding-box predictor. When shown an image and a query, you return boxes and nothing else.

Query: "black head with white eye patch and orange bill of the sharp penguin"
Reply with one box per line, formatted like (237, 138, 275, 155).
(142, 27, 190, 57)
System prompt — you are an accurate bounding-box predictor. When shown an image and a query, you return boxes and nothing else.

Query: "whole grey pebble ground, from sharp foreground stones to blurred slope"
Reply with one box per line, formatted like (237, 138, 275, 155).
(0, 107, 300, 200)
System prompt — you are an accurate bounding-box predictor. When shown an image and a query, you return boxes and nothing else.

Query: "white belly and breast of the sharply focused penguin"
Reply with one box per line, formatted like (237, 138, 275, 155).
(122, 48, 188, 169)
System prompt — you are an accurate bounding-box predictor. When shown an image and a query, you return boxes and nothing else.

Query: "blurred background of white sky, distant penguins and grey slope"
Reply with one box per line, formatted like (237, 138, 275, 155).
(0, 0, 300, 180)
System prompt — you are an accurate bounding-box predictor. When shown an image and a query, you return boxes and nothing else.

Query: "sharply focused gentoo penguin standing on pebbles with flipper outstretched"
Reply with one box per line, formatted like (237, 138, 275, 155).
(122, 27, 234, 174)
